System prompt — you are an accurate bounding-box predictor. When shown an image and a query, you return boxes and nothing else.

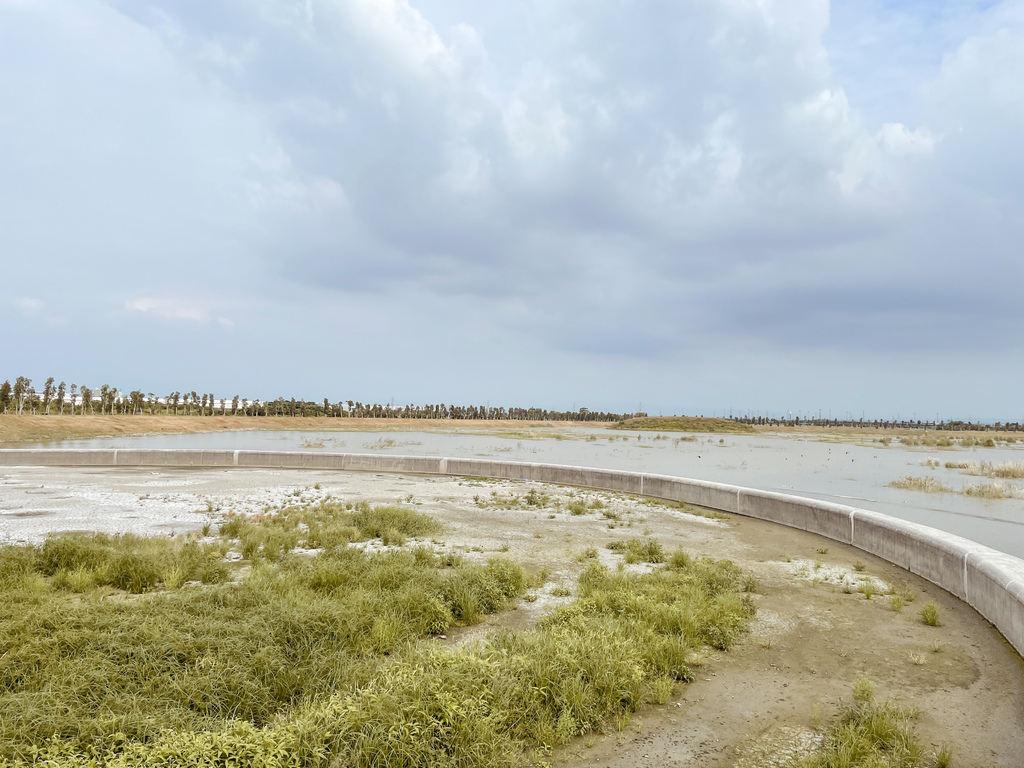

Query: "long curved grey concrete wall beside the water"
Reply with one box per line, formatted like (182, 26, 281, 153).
(0, 449, 1024, 653)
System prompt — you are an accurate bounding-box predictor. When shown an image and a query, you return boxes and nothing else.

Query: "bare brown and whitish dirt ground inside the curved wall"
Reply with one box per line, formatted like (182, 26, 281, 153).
(0, 468, 1024, 768)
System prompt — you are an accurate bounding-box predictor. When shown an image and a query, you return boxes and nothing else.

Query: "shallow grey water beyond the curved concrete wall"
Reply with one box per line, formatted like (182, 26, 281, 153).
(22, 427, 1024, 557)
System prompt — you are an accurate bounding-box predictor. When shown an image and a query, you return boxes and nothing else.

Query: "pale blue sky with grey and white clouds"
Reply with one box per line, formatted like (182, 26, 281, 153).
(0, 0, 1024, 421)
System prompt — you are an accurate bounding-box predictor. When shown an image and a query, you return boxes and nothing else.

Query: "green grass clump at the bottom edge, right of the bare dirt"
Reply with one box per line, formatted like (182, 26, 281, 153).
(797, 678, 925, 768)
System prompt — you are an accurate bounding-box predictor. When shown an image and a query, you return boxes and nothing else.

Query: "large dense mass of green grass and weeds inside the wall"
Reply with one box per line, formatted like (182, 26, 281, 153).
(0, 500, 753, 767)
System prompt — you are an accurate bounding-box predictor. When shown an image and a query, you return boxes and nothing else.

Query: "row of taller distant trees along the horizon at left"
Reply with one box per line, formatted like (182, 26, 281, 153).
(0, 376, 646, 422)
